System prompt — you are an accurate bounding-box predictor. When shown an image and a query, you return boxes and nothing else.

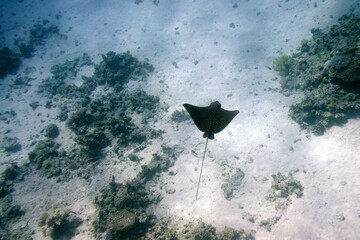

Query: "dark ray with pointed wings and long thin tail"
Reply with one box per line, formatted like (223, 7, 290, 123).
(183, 101, 239, 200)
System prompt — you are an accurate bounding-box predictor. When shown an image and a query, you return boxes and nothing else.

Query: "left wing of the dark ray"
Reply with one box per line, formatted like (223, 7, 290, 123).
(183, 103, 211, 132)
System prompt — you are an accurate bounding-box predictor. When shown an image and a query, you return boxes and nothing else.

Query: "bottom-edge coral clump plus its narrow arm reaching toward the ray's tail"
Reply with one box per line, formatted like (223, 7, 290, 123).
(94, 146, 177, 239)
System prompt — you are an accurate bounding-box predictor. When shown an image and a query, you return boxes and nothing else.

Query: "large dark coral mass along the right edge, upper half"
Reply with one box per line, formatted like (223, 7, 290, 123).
(274, 14, 360, 135)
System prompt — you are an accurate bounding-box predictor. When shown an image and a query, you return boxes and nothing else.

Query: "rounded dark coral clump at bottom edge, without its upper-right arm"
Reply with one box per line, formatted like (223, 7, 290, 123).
(93, 175, 158, 239)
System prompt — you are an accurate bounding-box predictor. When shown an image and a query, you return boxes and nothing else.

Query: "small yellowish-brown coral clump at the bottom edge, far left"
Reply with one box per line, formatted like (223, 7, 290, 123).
(38, 205, 82, 239)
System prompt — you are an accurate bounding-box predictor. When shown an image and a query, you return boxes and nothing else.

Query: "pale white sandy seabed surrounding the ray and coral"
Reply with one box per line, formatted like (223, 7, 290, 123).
(0, 0, 360, 239)
